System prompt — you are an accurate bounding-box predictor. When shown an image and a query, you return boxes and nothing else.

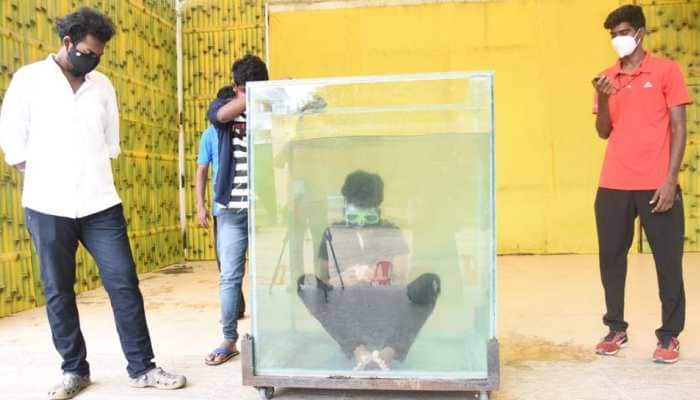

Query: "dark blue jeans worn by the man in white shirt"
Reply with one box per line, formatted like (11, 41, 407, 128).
(24, 205, 155, 378)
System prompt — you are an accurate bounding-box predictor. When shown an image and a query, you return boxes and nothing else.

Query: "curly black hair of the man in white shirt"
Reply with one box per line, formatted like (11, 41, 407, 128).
(55, 7, 114, 44)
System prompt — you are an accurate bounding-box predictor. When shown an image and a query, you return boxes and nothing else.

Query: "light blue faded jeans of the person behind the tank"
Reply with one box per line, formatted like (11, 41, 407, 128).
(216, 209, 248, 343)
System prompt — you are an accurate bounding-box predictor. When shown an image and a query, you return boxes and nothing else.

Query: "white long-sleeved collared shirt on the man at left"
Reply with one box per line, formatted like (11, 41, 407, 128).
(0, 55, 121, 218)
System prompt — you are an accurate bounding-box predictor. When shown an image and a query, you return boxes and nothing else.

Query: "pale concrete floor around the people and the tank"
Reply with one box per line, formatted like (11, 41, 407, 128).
(0, 254, 700, 400)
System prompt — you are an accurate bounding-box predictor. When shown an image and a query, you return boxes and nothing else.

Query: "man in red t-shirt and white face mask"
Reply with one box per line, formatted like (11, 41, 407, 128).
(593, 5, 691, 363)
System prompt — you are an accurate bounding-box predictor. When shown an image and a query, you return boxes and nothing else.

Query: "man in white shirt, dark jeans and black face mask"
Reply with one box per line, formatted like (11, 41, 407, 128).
(0, 8, 186, 400)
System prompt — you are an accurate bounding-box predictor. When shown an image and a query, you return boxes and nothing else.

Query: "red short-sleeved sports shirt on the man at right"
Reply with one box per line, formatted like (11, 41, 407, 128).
(593, 53, 691, 190)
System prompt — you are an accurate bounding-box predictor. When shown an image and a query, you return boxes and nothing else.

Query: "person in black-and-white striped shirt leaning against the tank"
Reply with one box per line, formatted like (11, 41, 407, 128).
(205, 55, 268, 365)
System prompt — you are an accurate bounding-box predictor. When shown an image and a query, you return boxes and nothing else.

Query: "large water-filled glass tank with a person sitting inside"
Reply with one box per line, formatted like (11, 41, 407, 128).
(247, 72, 496, 379)
